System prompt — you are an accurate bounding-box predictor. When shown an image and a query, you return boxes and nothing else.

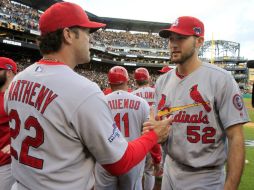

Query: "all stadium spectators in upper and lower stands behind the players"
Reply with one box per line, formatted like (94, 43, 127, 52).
(0, 0, 247, 92)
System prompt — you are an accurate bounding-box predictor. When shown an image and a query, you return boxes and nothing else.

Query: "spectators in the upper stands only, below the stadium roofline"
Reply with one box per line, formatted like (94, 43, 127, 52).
(0, 0, 169, 57)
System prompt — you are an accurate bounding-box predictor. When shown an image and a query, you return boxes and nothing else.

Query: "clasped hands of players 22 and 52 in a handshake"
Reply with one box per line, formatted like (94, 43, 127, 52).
(142, 107, 173, 143)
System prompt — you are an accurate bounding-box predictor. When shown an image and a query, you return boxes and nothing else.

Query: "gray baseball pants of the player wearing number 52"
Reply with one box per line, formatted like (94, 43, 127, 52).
(161, 155, 225, 190)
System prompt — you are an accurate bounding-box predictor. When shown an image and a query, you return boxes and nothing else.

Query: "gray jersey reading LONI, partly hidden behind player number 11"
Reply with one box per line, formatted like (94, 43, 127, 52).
(132, 86, 155, 106)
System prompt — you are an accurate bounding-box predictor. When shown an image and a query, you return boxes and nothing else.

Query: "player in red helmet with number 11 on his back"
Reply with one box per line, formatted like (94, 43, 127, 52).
(95, 66, 149, 190)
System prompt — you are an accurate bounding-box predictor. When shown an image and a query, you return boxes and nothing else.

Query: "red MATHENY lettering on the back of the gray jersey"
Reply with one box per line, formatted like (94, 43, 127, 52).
(8, 80, 58, 114)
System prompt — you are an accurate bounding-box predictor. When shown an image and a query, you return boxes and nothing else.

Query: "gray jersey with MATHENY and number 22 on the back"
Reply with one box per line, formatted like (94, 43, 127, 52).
(5, 63, 128, 190)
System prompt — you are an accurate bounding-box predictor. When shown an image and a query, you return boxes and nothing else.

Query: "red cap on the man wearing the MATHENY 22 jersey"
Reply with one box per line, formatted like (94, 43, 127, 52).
(39, 2, 106, 35)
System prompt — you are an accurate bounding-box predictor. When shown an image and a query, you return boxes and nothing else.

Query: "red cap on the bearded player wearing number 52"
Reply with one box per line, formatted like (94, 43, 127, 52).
(159, 16, 205, 38)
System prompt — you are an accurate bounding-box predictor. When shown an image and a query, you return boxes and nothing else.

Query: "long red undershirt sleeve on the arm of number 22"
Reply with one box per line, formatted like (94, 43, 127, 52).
(102, 131, 158, 176)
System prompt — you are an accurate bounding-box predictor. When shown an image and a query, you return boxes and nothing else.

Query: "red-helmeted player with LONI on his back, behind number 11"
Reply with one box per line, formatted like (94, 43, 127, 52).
(132, 67, 161, 190)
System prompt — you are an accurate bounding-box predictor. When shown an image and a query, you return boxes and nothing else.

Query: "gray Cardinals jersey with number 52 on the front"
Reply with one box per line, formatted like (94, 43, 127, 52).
(155, 63, 249, 189)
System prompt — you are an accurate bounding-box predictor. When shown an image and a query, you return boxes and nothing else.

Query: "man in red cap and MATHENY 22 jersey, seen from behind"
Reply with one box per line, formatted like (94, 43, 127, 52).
(4, 2, 170, 190)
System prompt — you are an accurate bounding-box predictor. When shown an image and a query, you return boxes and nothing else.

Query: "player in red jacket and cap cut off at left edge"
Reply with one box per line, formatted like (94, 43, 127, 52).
(0, 57, 17, 190)
